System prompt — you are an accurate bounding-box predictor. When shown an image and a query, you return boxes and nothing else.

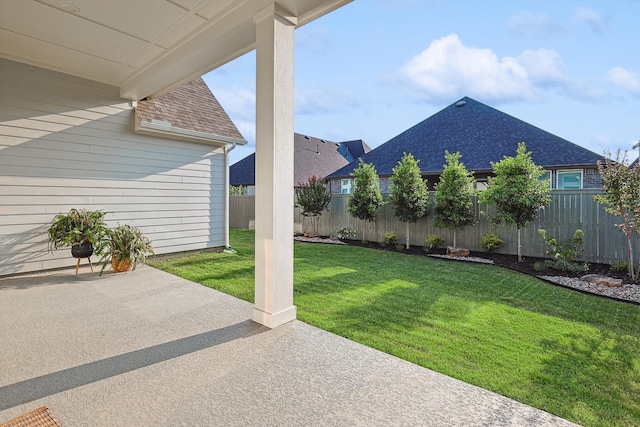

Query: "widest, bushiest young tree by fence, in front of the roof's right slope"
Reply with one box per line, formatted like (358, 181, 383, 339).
(480, 142, 551, 262)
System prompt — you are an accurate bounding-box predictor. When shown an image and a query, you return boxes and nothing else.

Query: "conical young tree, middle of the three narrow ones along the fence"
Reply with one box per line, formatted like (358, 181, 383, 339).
(389, 153, 429, 249)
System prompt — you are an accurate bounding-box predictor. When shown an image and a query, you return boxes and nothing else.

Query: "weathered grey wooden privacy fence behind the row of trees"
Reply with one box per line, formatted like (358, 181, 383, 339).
(229, 190, 638, 263)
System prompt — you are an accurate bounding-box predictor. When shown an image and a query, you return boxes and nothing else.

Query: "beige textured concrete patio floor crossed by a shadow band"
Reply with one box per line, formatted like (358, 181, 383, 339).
(0, 265, 575, 427)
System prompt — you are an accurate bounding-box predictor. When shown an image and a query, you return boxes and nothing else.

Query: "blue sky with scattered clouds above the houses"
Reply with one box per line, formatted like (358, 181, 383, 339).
(203, 0, 640, 164)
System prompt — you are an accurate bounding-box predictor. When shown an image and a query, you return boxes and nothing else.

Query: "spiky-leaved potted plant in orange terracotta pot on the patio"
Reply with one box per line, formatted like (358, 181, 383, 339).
(100, 224, 155, 274)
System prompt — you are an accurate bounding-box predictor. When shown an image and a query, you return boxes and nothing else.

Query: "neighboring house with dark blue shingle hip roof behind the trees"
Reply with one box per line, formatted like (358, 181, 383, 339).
(327, 97, 603, 193)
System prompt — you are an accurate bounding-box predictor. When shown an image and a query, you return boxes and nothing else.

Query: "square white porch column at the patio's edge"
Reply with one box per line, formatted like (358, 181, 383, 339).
(252, 4, 297, 328)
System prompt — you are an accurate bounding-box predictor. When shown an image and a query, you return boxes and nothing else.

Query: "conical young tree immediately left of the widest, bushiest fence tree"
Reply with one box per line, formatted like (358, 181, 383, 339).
(433, 151, 476, 247)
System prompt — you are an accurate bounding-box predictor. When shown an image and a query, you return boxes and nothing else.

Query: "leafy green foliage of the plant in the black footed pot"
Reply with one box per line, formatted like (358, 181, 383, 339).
(47, 208, 107, 254)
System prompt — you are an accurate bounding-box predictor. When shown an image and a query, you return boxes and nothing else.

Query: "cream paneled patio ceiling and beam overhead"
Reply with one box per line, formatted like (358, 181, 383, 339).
(0, 0, 351, 101)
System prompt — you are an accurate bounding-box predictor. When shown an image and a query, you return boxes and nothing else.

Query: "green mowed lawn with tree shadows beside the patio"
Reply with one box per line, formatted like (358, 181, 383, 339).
(152, 230, 640, 427)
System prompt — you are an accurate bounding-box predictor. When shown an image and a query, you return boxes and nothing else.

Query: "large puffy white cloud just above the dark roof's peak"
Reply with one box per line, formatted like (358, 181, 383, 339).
(401, 34, 567, 101)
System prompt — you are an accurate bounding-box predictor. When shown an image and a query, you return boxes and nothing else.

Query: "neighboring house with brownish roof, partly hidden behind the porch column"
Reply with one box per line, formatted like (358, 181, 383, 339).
(229, 133, 371, 195)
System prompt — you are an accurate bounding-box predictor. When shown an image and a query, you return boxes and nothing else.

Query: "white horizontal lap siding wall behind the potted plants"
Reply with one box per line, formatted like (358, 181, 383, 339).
(0, 60, 225, 275)
